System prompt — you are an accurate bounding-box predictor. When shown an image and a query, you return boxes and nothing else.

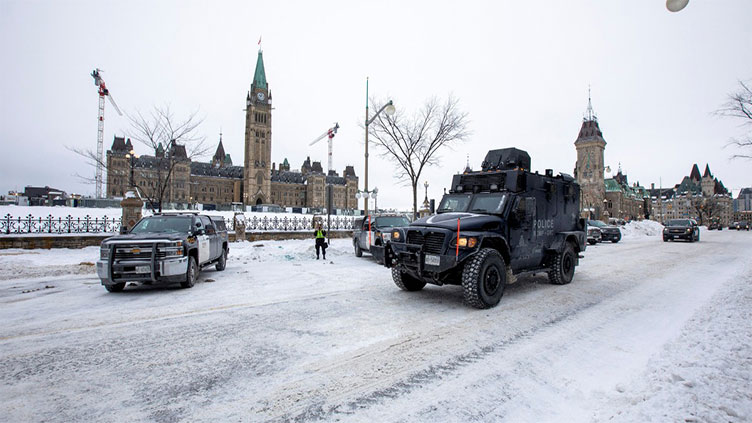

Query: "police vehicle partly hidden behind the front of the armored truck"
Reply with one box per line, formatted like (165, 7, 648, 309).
(353, 215, 410, 263)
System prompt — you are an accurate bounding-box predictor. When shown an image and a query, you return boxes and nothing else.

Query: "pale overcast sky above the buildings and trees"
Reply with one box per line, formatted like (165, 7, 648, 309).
(0, 0, 752, 208)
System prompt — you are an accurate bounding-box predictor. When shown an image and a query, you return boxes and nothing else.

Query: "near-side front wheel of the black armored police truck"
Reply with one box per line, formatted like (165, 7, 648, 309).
(462, 248, 507, 309)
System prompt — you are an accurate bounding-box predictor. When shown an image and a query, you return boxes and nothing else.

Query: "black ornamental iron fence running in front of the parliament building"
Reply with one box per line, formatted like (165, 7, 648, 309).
(0, 214, 356, 235)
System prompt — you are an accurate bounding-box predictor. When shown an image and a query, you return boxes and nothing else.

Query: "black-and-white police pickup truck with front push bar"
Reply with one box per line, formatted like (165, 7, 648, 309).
(97, 213, 230, 292)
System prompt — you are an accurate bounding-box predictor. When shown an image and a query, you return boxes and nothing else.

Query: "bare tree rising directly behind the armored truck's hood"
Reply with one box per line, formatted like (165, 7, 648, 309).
(368, 95, 470, 219)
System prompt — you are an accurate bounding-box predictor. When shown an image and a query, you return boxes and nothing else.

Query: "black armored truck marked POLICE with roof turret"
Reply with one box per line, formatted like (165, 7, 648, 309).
(384, 148, 586, 309)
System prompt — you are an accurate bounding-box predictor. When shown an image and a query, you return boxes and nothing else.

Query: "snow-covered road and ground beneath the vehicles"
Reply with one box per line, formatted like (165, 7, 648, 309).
(0, 230, 752, 422)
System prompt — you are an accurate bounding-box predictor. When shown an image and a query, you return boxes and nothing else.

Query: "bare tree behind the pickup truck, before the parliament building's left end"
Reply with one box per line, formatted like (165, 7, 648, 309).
(126, 105, 209, 212)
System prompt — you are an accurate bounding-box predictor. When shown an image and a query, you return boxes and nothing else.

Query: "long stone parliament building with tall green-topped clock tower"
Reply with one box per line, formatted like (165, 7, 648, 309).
(107, 50, 358, 210)
